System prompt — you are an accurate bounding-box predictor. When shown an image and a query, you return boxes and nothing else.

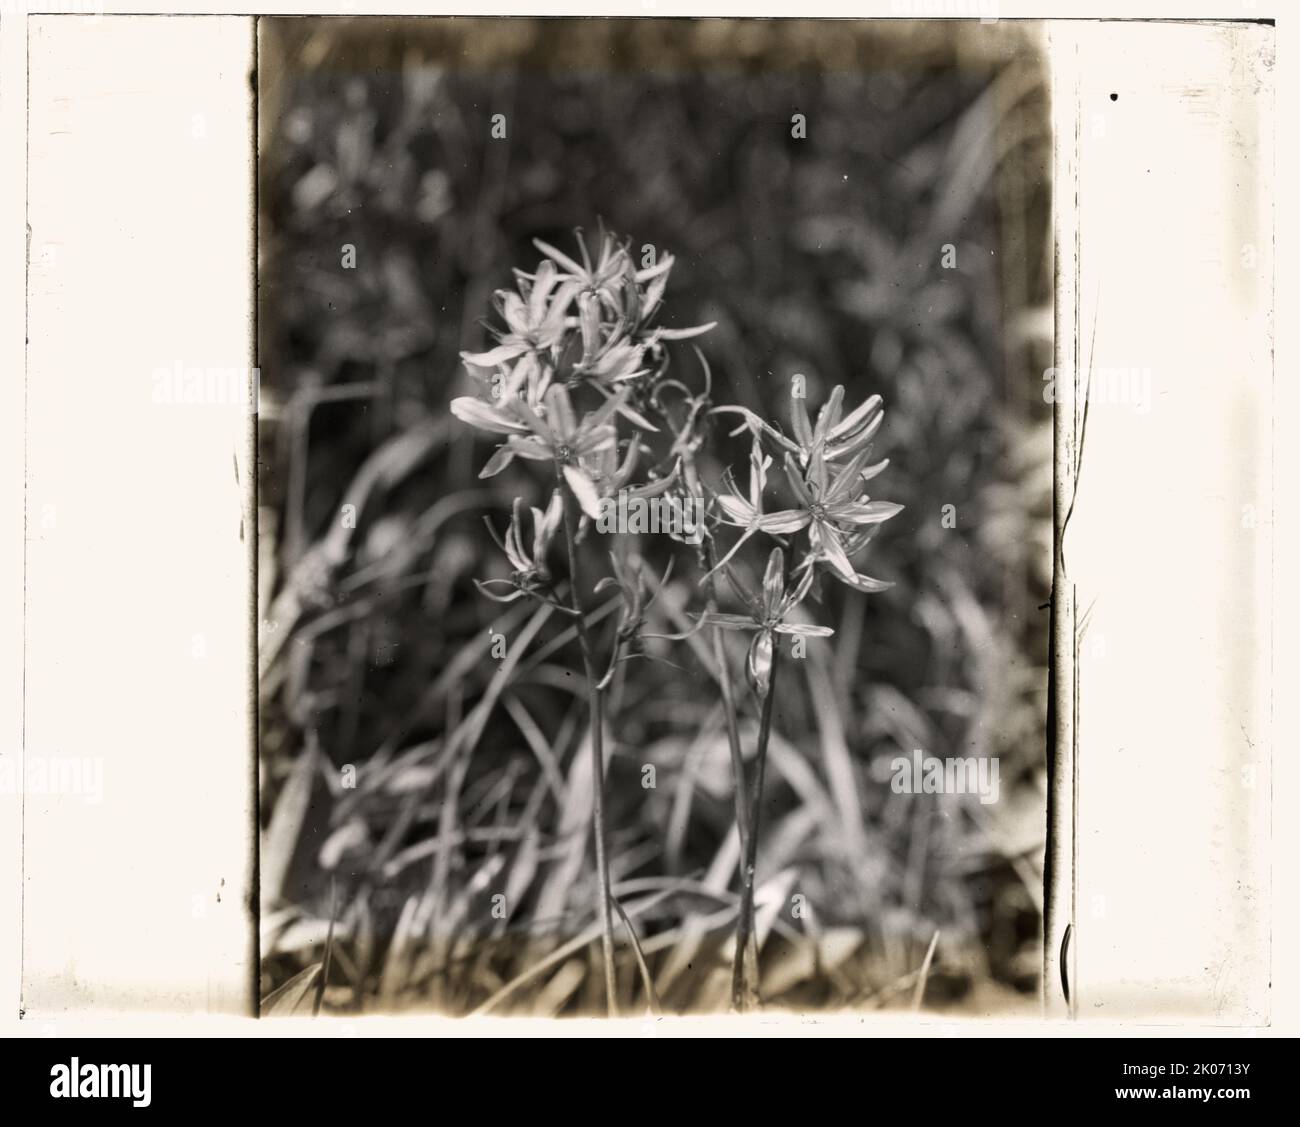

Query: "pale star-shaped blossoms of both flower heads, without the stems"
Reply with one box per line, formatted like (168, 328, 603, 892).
(451, 228, 901, 681)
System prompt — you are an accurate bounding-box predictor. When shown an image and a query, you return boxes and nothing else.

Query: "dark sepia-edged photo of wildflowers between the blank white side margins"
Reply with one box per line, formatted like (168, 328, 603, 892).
(259, 19, 1053, 1017)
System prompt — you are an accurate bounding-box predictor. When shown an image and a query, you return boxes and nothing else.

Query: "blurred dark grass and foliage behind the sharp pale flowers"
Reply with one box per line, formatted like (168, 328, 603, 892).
(259, 19, 1052, 1014)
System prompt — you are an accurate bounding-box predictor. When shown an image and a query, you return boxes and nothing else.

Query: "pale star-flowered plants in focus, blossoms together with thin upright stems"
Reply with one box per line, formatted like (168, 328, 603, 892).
(451, 227, 901, 1014)
